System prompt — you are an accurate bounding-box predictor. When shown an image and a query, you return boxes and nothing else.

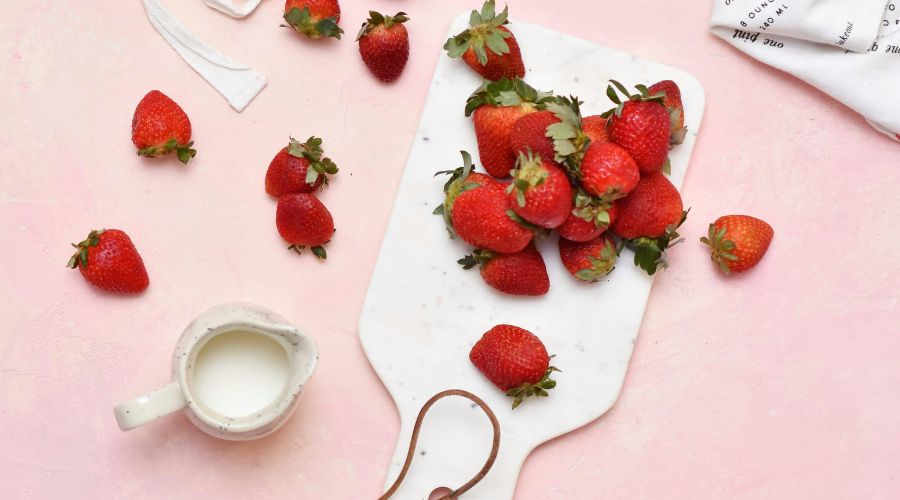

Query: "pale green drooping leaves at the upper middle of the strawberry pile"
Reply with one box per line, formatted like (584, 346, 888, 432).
(546, 96, 591, 180)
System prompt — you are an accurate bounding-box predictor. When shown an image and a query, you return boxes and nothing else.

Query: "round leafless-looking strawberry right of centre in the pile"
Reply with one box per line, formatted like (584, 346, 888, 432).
(579, 142, 641, 201)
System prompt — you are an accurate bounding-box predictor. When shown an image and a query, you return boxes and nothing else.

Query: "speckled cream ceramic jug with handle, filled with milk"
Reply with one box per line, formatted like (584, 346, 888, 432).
(114, 303, 318, 440)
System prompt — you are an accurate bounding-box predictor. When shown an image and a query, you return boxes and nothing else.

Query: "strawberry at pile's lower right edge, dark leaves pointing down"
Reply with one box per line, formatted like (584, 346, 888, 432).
(612, 172, 687, 275)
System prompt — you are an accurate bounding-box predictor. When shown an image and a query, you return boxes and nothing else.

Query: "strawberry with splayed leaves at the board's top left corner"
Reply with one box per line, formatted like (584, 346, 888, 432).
(444, 0, 525, 80)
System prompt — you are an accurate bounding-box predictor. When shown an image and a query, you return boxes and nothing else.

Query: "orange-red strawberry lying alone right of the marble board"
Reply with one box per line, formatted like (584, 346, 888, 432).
(700, 215, 775, 274)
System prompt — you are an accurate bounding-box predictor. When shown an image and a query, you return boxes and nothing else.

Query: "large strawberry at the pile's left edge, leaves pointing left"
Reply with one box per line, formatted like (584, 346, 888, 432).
(434, 151, 538, 253)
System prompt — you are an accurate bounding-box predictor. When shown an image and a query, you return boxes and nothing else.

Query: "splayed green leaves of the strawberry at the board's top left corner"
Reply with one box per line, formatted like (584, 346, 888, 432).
(444, 0, 512, 66)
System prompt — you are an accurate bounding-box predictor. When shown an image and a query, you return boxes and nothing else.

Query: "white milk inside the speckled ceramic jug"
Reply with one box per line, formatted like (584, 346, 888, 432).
(193, 331, 290, 418)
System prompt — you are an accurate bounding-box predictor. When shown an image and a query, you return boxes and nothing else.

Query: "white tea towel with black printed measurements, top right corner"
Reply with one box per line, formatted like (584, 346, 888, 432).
(710, 0, 900, 141)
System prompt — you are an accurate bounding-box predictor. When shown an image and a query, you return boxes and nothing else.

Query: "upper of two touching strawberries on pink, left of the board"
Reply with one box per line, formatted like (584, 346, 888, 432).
(266, 137, 338, 197)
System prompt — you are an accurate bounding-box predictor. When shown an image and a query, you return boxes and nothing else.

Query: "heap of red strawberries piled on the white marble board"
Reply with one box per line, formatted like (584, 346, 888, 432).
(435, 0, 687, 295)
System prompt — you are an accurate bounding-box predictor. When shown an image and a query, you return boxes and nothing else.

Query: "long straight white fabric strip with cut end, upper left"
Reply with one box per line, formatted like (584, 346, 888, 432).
(144, 0, 266, 111)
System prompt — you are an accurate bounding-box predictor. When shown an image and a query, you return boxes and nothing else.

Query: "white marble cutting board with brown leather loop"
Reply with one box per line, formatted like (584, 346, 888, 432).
(359, 13, 705, 500)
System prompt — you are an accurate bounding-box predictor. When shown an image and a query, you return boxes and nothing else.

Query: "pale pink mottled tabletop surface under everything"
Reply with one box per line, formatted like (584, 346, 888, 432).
(0, 0, 900, 499)
